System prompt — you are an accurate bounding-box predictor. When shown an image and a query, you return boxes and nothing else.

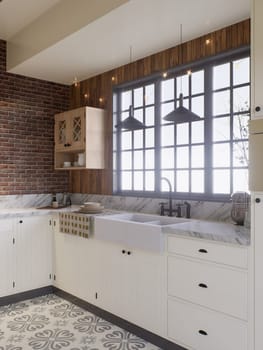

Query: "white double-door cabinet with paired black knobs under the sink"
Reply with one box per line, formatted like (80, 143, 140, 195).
(98, 241, 165, 336)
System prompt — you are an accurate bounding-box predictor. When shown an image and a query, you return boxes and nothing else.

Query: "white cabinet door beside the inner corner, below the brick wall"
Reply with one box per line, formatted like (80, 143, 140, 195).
(15, 216, 52, 292)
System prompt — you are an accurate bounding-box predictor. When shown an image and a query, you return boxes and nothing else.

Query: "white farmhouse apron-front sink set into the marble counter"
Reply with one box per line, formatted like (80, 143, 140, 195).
(94, 213, 188, 252)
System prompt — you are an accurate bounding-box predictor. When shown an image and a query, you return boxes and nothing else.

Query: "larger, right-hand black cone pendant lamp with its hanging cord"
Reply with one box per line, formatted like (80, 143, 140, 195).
(163, 24, 202, 124)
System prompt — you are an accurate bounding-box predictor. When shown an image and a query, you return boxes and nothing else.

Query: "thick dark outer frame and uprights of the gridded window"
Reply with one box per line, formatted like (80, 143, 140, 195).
(113, 46, 251, 202)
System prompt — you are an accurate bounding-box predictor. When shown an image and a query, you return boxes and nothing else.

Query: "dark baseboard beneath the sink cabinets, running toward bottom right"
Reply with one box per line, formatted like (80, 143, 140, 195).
(53, 287, 187, 350)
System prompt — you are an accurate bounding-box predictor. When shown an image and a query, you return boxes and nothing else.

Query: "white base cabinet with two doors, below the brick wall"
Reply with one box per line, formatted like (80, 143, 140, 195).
(0, 216, 52, 296)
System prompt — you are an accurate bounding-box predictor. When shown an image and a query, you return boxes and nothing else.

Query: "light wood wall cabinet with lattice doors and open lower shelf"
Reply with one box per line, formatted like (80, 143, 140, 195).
(54, 107, 105, 170)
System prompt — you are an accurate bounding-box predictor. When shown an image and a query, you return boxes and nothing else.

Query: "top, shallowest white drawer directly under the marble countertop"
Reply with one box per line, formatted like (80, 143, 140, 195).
(167, 236, 248, 268)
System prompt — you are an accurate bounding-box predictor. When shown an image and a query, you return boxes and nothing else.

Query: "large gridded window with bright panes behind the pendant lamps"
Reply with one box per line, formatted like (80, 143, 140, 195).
(113, 51, 250, 200)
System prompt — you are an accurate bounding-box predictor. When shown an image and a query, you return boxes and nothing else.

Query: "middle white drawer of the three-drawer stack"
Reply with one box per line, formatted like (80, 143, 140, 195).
(168, 257, 247, 319)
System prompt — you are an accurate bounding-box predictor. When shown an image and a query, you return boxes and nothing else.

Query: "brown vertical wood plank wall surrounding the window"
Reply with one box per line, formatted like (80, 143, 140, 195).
(69, 19, 250, 195)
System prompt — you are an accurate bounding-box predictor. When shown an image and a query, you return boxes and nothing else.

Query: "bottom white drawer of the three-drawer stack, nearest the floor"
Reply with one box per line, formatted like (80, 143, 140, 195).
(168, 299, 248, 350)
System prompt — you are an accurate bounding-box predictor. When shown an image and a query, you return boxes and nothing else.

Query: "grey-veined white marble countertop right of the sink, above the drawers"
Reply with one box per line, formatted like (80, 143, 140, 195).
(163, 220, 250, 245)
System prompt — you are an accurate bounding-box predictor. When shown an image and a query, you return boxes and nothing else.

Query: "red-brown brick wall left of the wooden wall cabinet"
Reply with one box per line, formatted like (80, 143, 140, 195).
(0, 40, 70, 195)
